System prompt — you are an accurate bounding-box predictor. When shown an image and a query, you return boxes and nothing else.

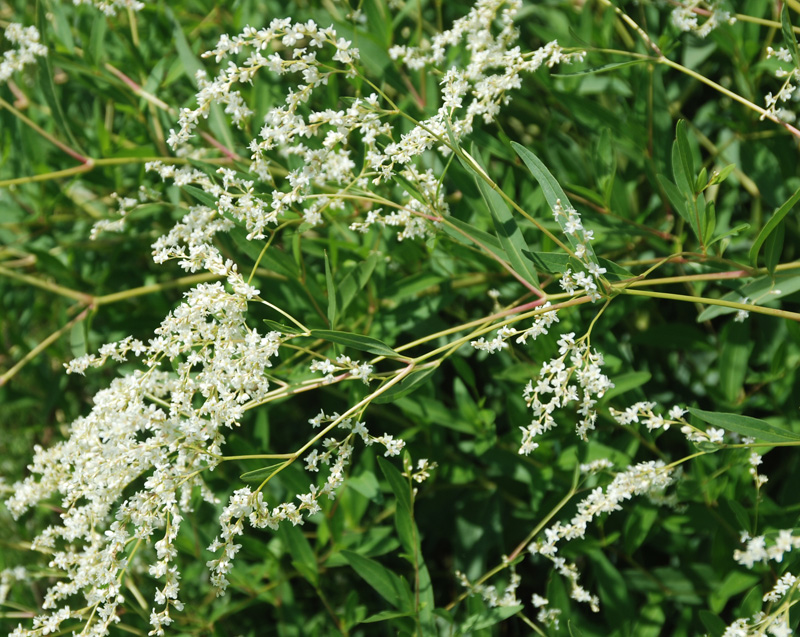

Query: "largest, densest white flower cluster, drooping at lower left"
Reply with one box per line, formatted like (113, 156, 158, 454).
(7, 270, 290, 635)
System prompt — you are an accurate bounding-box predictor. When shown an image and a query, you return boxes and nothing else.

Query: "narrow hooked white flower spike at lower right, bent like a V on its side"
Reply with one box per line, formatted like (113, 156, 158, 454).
(528, 460, 673, 612)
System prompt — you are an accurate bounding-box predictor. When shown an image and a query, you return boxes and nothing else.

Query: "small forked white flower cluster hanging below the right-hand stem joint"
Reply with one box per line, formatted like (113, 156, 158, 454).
(519, 332, 614, 455)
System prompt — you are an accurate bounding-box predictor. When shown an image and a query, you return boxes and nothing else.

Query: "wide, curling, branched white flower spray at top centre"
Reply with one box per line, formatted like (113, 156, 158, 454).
(153, 0, 582, 251)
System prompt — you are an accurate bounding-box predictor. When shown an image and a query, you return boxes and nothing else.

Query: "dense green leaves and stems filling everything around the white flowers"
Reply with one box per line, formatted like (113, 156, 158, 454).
(0, 0, 800, 637)
